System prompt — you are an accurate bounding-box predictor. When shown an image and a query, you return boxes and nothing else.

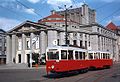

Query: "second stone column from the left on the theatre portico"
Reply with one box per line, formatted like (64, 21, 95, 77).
(12, 34, 16, 63)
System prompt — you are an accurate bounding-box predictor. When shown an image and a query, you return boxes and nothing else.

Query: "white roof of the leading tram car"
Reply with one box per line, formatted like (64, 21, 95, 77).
(47, 46, 87, 51)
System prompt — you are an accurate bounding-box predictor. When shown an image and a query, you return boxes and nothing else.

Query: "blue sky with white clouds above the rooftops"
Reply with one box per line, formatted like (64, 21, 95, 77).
(0, 0, 120, 31)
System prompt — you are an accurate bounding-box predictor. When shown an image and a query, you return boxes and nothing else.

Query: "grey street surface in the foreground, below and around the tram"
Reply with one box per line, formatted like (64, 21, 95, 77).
(0, 63, 120, 82)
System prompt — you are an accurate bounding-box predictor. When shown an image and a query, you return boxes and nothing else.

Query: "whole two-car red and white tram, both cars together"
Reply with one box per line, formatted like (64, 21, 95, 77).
(46, 46, 112, 74)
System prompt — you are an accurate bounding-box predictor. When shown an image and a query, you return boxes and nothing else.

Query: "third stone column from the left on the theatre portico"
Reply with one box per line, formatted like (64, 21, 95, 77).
(21, 34, 26, 63)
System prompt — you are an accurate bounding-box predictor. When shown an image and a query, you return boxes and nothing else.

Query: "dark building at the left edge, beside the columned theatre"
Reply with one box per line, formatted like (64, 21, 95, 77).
(0, 29, 6, 64)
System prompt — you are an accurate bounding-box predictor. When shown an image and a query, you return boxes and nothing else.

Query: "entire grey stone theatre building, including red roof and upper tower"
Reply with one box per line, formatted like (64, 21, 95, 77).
(6, 4, 120, 64)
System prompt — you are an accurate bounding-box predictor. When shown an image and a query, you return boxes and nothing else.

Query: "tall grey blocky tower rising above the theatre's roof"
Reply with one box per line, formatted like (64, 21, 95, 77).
(56, 4, 96, 25)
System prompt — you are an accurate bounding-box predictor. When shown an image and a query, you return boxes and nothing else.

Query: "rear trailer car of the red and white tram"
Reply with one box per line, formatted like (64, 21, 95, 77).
(87, 51, 113, 68)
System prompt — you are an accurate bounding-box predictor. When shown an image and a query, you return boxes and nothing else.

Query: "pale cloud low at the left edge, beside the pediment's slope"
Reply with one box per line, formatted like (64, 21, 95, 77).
(0, 17, 21, 31)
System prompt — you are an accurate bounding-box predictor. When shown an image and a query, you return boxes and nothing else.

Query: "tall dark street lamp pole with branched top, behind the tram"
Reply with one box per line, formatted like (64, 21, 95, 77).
(58, 5, 72, 45)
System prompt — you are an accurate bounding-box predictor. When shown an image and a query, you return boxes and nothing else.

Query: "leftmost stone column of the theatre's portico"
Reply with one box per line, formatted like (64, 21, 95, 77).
(6, 35, 12, 64)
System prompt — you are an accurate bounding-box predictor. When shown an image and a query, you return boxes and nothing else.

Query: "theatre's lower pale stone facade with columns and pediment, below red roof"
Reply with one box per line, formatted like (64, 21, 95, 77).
(7, 21, 118, 64)
